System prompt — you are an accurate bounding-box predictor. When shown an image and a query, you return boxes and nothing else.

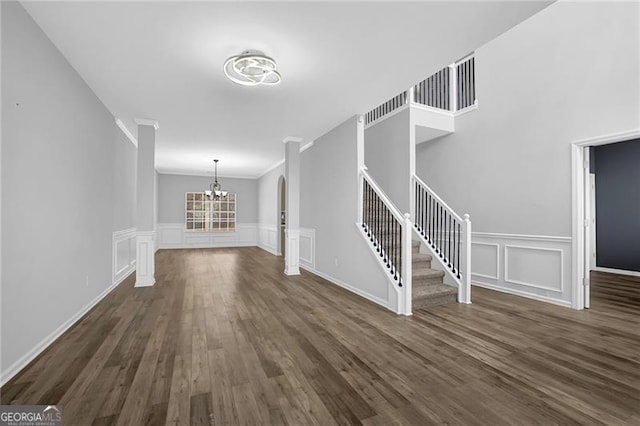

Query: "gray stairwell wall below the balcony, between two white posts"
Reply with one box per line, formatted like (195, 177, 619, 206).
(364, 109, 411, 213)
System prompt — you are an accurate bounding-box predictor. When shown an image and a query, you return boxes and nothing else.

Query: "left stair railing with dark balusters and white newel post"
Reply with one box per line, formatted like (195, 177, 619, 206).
(359, 168, 412, 315)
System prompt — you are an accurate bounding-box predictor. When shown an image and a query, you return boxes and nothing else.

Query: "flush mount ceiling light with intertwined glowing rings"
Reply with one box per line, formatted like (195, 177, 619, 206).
(224, 50, 282, 86)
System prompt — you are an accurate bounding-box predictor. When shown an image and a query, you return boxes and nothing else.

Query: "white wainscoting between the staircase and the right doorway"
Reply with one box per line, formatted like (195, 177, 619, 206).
(471, 232, 572, 306)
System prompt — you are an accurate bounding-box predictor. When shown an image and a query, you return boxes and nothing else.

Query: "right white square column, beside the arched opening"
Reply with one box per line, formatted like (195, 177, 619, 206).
(283, 137, 302, 275)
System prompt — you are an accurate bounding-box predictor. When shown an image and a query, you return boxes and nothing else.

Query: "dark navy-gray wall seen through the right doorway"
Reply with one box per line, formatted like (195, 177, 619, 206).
(592, 139, 640, 272)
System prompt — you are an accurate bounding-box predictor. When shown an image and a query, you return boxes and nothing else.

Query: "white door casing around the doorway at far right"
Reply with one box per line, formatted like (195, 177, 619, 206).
(571, 128, 640, 309)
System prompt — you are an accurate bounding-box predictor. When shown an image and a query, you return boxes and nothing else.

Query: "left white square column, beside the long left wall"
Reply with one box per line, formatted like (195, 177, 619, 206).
(135, 119, 158, 287)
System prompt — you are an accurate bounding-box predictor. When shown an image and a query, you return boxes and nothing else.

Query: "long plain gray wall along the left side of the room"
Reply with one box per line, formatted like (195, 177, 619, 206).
(0, 2, 122, 379)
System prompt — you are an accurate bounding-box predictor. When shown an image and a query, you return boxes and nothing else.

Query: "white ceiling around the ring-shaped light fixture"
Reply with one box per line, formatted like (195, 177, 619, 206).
(23, 1, 550, 177)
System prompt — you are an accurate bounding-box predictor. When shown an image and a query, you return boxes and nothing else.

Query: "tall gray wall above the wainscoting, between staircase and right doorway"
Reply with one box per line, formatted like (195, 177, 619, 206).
(416, 2, 640, 236)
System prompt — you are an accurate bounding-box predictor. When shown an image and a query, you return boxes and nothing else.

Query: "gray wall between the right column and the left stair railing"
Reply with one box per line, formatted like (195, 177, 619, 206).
(300, 117, 396, 300)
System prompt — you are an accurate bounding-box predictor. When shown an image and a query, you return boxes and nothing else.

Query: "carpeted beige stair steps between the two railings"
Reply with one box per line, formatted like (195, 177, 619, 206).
(411, 240, 458, 310)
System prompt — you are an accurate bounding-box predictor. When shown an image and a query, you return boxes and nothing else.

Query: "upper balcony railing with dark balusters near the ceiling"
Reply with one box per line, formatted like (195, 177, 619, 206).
(365, 54, 476, 125)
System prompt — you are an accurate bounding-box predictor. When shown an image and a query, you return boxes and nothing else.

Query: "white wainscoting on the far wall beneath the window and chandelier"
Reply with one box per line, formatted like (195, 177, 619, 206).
(157, 223, 258, 249)
